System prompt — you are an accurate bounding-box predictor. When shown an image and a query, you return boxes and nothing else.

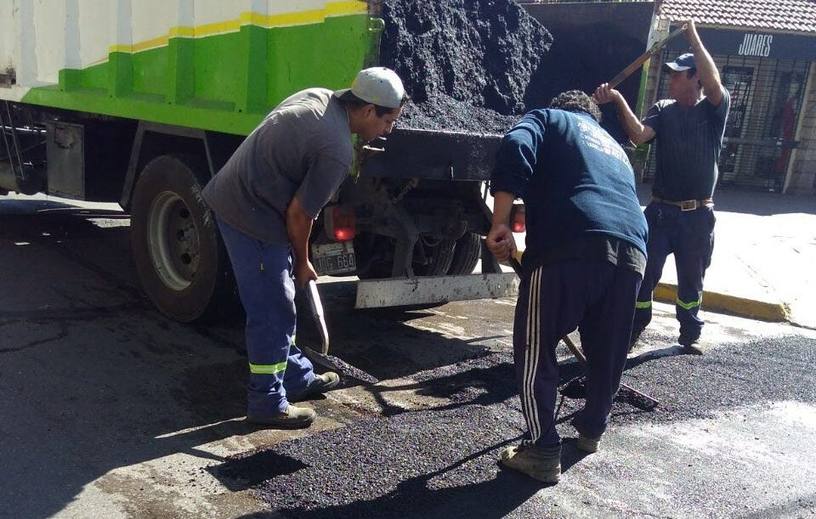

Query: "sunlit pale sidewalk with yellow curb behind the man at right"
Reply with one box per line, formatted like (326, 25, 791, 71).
(638, 184, 816, 328)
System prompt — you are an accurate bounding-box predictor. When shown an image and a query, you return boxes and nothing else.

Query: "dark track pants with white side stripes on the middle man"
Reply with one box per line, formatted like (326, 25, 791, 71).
(513, 261, 641, 447)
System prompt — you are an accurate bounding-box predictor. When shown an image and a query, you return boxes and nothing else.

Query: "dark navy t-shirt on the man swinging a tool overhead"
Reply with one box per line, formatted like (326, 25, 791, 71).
(643, 87, 731, 201)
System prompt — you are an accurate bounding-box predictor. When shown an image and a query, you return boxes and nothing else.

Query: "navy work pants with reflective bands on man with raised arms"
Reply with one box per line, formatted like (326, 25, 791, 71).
(633, 202, 716, 340)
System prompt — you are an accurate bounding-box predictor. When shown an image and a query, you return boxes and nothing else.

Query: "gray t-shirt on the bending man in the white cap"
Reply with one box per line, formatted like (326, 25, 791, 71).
(202, 88, 354, 244)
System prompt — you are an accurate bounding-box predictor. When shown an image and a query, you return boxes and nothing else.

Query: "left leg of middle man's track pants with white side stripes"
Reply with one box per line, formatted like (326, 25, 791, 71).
(513, 264, 583, 447)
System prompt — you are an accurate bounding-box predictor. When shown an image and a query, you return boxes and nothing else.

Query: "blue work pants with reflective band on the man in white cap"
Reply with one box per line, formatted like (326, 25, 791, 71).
(218, 219, 315, 416)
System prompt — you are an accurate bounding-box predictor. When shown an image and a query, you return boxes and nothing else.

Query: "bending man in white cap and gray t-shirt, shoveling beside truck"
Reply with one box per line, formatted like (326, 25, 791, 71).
(202, 67, 407, 428)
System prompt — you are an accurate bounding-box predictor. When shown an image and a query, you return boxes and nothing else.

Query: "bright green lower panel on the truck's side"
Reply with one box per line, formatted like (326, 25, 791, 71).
(23, 14, 372, 135)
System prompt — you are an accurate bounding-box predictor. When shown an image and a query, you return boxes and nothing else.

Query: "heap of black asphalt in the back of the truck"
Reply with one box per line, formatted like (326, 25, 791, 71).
(380, 0, 553, 133)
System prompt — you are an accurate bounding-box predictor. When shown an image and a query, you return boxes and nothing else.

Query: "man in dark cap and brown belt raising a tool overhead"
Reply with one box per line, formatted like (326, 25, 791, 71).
(593, 21, 731, 354)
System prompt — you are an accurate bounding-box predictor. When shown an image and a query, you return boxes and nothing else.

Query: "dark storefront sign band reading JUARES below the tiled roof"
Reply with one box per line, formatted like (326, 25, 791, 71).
(671, 28, 816, 61)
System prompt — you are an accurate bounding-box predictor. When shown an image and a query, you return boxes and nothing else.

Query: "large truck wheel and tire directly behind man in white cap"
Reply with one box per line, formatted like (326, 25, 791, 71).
(131, 155, 234, 323)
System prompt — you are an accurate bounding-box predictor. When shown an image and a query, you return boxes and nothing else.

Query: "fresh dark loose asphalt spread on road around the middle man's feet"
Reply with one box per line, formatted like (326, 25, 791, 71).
(242, 336, 816, 518)
